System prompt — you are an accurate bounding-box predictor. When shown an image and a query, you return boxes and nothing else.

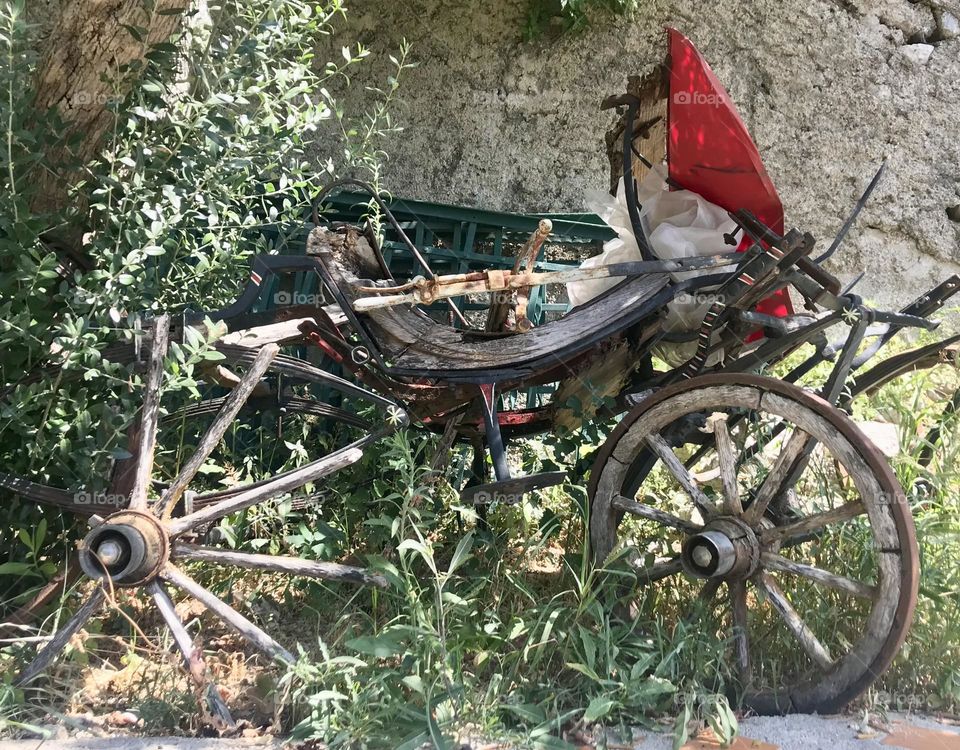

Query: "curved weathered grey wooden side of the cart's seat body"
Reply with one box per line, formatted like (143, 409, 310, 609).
(307, 227, 672, 383)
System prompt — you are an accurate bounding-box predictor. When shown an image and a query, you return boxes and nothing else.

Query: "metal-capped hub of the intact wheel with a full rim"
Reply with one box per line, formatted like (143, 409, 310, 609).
(680, 517, 760, 579)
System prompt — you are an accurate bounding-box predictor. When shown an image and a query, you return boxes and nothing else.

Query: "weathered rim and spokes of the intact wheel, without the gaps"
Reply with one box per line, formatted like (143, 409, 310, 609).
(589, 374, 919, 714)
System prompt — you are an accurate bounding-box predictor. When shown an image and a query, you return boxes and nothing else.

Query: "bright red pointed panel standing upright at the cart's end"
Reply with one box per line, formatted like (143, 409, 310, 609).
(667, 28, 793, 316)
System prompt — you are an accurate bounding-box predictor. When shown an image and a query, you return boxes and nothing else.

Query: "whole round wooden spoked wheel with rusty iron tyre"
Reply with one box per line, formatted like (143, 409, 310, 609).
(590, 374, 919, 713)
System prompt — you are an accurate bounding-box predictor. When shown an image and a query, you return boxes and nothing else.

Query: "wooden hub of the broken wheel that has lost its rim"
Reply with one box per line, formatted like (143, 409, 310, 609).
(80, 510, 170, 586)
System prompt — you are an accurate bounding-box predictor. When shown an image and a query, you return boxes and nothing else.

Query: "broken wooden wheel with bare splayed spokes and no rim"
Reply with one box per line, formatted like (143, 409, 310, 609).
(0, 316, 406, 725)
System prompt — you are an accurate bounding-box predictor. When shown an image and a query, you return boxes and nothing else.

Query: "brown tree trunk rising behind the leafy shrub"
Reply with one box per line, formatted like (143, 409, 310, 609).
(35, 0, 189, 220)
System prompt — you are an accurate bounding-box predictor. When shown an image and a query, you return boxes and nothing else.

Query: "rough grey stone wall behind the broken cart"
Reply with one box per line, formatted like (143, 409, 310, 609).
(320, 0, 960, 304)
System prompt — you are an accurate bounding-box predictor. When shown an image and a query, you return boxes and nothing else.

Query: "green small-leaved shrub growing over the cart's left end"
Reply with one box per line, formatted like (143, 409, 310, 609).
(0, 0, 408, 606)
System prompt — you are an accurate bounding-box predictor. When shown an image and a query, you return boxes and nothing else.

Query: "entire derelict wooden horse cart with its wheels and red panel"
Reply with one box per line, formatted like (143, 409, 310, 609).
(0, 27, 958, 723)
